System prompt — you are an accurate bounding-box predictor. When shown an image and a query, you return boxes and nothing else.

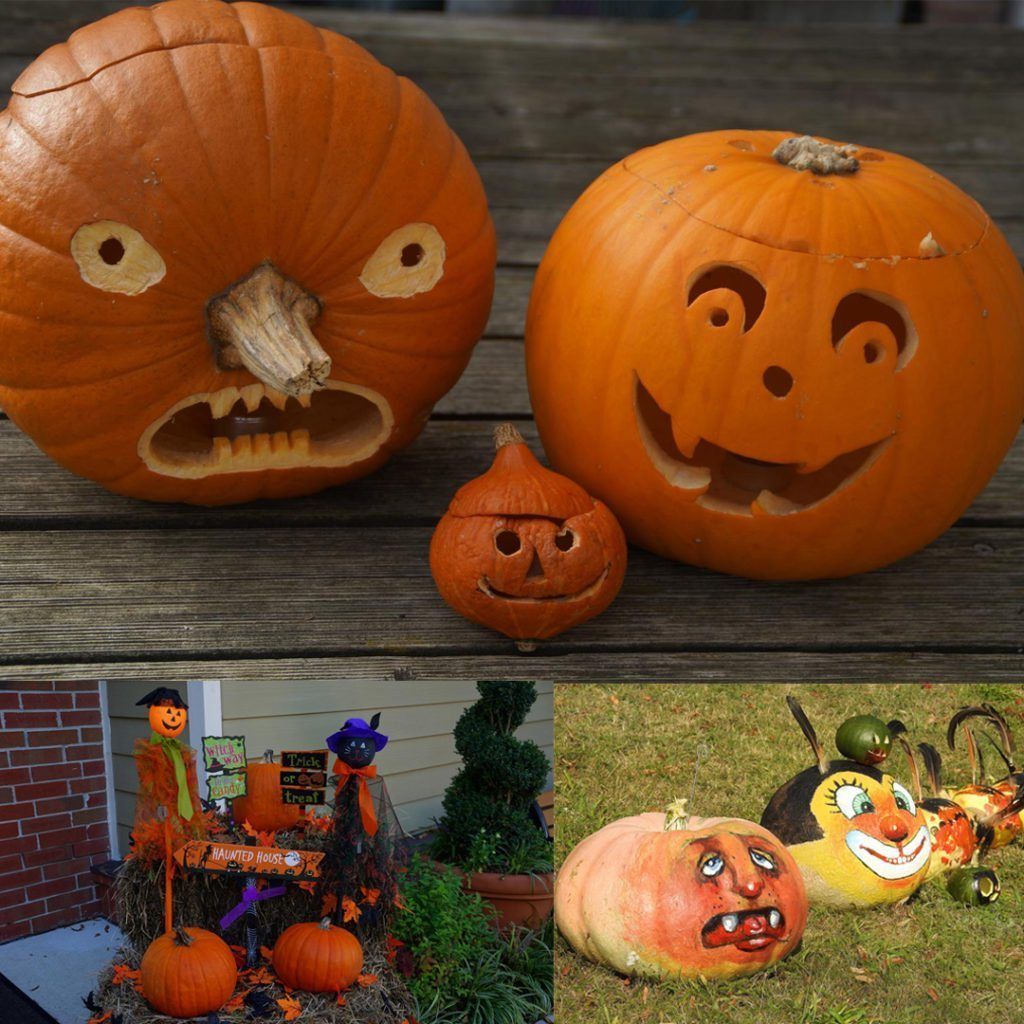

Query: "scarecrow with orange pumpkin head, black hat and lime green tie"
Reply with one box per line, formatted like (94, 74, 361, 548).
(132, 686, 206, 932)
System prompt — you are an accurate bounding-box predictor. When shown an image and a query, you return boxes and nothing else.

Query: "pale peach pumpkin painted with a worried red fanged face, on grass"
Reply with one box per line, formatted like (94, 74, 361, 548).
(555, 805, 807, 978)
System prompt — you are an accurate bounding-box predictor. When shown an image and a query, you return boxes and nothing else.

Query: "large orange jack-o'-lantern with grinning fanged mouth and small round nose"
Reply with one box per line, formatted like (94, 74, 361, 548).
(526, 131, 1024, 579)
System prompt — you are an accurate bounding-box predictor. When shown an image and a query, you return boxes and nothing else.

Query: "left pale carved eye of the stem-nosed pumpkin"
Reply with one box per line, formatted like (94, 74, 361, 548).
(71, 220, 167, 295)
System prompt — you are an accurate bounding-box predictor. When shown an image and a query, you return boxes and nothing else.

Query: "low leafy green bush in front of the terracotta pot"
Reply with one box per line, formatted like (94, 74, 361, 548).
(392, 857, 554, 1024)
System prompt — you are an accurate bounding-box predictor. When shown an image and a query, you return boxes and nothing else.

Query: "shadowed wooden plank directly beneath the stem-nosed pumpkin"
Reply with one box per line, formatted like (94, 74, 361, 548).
(0, 413, 1024, 530)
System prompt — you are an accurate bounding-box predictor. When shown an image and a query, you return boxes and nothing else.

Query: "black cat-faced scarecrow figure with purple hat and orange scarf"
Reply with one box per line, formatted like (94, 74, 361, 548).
(327, 712, 402, 938)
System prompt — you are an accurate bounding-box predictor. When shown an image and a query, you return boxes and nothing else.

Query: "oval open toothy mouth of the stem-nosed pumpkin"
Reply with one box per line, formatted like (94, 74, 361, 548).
(138, 380, 394, 479)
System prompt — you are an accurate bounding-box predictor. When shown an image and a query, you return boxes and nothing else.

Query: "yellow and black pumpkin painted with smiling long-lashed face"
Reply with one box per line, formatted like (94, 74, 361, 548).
(761, 761, 932, 906)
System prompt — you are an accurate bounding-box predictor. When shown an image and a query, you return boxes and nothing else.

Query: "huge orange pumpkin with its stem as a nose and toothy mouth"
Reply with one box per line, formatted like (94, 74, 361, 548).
(0, 0, 495, 505)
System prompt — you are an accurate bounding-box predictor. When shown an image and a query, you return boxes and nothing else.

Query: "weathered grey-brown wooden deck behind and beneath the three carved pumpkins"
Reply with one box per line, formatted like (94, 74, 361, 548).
(0, 6, 1024, 679)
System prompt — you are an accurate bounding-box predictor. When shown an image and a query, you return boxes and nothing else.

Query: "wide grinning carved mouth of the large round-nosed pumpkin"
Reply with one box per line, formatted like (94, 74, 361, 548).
(634, 375, 892, 515)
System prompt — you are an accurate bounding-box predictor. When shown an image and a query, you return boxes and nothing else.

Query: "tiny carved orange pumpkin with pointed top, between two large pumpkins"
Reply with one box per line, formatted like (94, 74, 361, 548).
(430, 423, 626, 639)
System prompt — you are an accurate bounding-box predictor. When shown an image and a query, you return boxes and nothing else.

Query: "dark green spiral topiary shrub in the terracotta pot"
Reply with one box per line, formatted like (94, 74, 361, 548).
(433, 682, 551, 873)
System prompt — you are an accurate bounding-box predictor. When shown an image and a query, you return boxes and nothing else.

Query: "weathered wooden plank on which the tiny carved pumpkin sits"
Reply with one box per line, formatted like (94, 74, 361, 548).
(0, 526, 1024, 672)
